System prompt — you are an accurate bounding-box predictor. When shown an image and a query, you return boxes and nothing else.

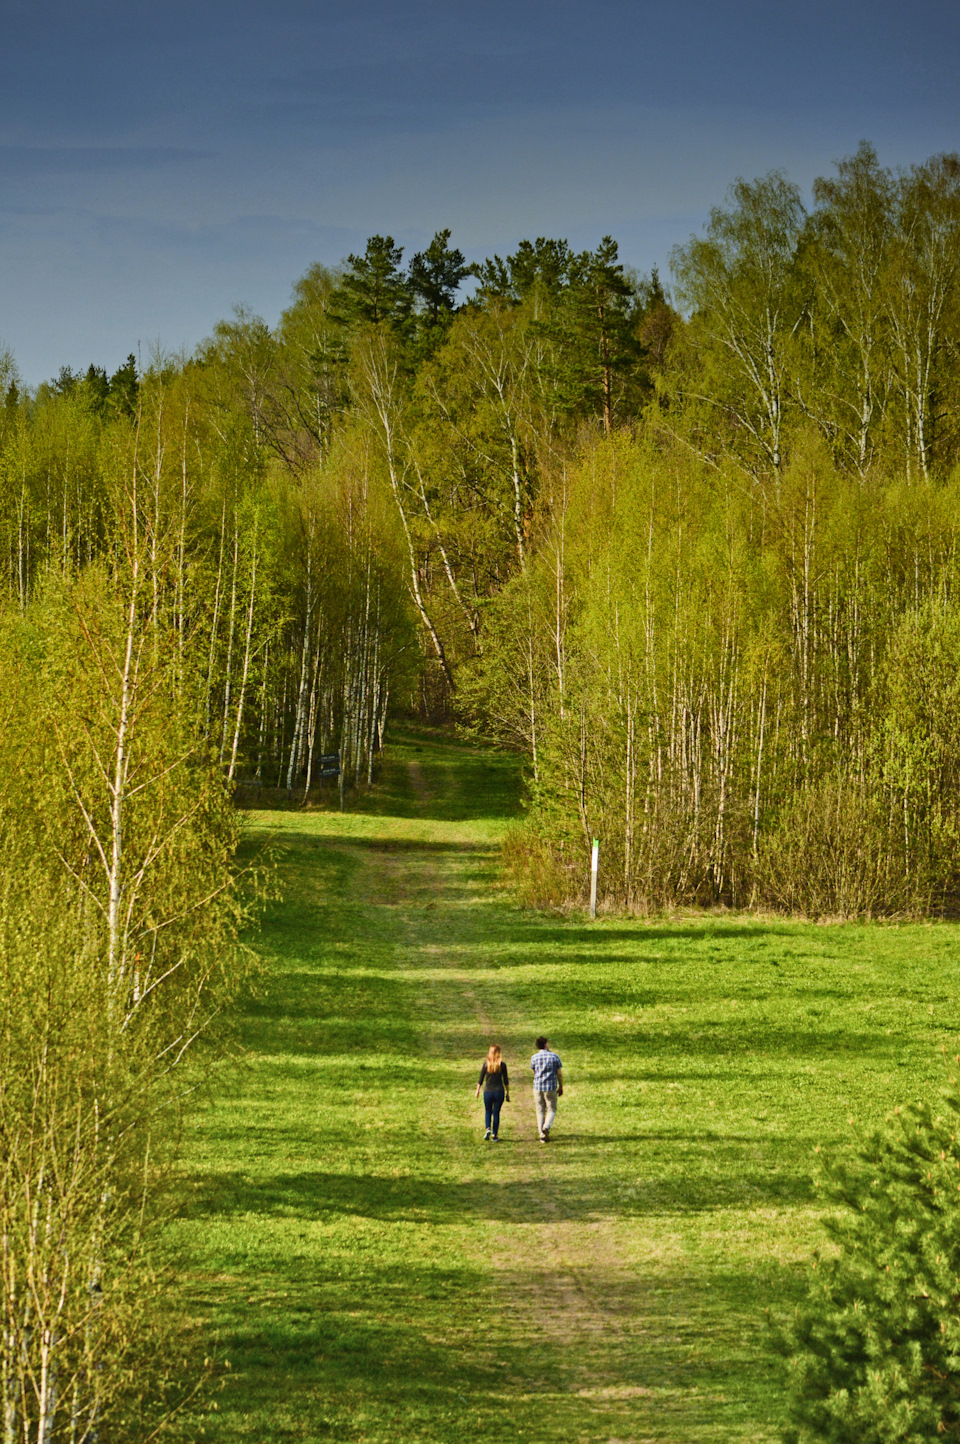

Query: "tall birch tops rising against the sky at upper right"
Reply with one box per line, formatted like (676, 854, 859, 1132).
(664, 142, 960, 479)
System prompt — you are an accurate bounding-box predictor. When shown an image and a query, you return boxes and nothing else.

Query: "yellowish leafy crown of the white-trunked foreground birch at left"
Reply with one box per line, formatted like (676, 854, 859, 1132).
(20, 567, 248, 1028)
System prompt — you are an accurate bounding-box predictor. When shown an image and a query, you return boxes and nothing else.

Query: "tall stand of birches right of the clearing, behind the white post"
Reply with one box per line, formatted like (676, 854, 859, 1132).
(487, 144, 960, 915)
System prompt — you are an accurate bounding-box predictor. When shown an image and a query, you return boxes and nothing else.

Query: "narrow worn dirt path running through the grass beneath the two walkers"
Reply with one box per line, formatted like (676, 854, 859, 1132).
(381, 762, 652, 1444)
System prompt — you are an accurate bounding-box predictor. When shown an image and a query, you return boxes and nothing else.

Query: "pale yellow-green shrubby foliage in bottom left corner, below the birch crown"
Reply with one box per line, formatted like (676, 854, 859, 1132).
(0, 877, 176, 1441)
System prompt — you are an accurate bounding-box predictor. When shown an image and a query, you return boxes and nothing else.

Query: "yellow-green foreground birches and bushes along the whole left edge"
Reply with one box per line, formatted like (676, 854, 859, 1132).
(0, 519, 250, 1441)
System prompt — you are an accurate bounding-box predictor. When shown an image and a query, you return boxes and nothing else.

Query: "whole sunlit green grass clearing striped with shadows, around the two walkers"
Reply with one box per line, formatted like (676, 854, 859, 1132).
(173, 732, 960, 1444)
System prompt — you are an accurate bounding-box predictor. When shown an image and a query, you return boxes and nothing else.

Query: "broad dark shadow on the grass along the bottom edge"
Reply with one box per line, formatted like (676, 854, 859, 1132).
(177, 1256, 800, 1444)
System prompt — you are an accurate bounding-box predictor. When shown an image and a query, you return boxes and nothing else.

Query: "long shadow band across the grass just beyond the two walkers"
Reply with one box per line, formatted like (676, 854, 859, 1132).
(232, 964, 904, 1068)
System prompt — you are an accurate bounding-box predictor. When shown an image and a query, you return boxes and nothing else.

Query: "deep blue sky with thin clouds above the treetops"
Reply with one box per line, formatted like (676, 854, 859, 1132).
(0, 0, 960, 384)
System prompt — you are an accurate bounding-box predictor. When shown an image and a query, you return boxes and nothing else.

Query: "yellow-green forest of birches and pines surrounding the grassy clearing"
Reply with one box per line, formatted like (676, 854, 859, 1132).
(0, 143, 960, 1441)
